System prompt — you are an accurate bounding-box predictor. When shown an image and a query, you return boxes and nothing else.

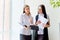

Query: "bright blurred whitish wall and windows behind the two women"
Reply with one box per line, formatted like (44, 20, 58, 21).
(0, 0, 60, 40)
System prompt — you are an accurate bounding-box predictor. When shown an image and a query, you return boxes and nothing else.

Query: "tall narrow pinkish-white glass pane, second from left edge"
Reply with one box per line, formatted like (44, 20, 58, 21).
(4, 0, 10, 31)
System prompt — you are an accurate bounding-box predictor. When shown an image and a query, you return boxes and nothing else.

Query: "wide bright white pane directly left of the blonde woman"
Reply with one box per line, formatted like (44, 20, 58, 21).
(11, 0, 24, 40)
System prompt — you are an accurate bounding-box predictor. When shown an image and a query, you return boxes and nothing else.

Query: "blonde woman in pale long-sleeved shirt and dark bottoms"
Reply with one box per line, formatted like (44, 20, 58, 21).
(20, 5, 33, 40)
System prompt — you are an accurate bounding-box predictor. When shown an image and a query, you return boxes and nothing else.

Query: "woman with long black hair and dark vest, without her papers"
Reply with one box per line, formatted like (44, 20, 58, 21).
(36, 5, 50, 40)
